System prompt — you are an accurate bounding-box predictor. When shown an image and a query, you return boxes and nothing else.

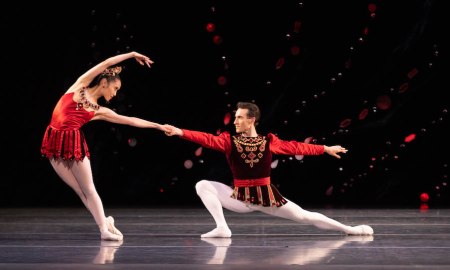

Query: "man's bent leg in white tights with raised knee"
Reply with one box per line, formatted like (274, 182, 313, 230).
(195, 180, 253, 237)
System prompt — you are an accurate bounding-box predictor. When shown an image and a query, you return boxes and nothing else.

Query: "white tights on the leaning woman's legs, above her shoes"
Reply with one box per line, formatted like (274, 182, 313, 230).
(50, 158, 108, 232)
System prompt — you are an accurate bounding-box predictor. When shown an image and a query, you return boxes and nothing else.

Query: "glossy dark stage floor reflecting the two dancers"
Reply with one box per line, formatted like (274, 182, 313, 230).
(0, 208, 450, 270)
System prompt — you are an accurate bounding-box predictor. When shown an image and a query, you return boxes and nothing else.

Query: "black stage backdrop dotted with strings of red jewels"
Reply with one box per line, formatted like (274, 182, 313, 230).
(0, 0, 450, 208)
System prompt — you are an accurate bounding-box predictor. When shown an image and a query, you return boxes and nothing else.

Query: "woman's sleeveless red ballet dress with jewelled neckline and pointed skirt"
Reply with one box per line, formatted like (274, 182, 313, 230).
(41, 92, 95, 161)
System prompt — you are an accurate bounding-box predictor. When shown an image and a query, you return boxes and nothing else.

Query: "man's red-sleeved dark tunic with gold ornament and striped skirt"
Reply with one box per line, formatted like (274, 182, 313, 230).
(182, 129, 324, 207)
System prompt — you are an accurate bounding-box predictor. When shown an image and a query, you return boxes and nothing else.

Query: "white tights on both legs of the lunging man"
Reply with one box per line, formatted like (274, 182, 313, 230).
(195, 180, 373, 237)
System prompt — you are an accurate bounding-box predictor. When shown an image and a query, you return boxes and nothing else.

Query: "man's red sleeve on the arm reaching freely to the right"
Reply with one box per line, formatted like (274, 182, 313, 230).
(267, 133, 325, 155)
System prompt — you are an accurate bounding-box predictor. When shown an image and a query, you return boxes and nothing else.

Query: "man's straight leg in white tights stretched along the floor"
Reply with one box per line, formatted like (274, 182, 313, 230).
(252, 200, 373, 235)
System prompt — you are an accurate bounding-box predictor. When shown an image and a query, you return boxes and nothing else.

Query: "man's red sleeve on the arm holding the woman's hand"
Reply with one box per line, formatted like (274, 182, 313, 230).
(181, 129, 231, 153)
